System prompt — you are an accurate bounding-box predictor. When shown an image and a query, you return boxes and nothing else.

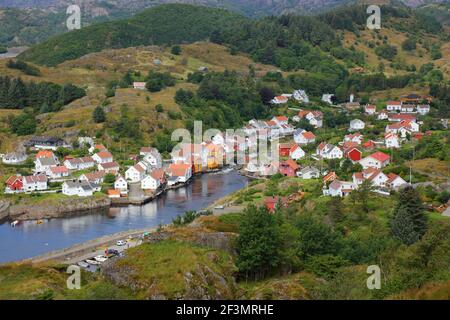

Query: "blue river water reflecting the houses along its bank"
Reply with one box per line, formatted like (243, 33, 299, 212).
(0, 171, 247, 263)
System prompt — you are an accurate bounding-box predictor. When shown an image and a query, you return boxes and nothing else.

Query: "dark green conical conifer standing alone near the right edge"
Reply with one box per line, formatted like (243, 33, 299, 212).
(391, 187, 427, 245)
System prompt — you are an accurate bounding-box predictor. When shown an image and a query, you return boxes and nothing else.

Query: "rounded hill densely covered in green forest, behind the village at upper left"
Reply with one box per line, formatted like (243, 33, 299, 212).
(21, 4, 246, 66)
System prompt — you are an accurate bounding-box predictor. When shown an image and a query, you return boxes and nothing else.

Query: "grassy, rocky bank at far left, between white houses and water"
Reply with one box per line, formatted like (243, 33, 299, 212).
(0, 197, 111, 221)
